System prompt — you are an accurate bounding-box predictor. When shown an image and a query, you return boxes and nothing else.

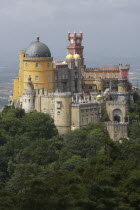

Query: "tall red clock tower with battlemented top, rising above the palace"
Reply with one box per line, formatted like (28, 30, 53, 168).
(67, 32, 84, 65)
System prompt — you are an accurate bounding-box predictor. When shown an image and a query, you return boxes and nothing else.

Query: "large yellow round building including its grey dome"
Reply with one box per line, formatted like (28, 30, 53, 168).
(13, 37, 54, 100)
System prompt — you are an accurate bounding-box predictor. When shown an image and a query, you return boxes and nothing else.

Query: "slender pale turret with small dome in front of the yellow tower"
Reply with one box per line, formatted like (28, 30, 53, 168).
(22, 77, 35, 113)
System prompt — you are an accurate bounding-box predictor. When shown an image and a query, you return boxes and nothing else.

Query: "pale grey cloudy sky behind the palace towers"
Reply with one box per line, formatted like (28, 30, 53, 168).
(0, 0, 140, 65)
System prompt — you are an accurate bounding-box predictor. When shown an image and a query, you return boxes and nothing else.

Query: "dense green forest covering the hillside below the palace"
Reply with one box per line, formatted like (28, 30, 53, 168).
(0, 105, 140, 210)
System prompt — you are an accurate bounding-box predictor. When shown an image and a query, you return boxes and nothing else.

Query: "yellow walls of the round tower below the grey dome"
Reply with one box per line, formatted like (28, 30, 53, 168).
(13, 51, 54, 99)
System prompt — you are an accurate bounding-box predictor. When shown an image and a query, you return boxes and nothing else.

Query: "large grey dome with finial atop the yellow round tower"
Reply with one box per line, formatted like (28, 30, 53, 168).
(25, 37, 51, 57)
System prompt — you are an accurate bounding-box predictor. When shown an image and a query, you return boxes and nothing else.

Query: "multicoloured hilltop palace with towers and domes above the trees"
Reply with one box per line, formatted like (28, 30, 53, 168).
(11, 33, 133, 140)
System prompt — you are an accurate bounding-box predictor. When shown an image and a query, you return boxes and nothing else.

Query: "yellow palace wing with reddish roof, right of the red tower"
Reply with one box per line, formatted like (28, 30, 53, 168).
(81, 64, 130, 92)
